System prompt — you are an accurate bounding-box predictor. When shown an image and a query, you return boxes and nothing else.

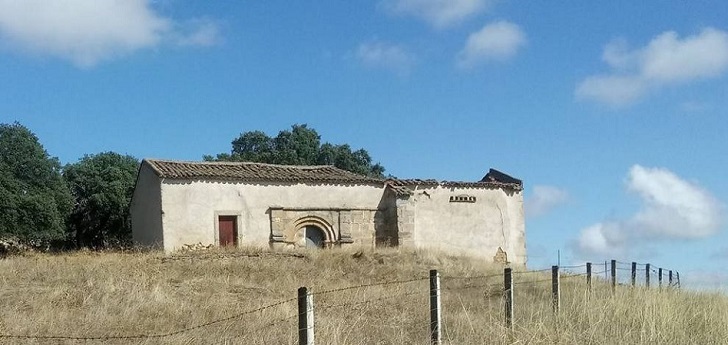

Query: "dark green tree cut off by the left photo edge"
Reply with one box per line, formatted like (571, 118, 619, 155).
(0, 122, 72, 245)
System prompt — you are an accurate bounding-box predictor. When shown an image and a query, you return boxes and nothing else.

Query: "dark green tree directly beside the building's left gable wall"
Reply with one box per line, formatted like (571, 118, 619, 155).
(63, 152, 139, 248)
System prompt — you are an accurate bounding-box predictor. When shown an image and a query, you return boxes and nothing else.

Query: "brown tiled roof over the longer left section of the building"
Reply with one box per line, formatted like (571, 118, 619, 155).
(142, 159, 385, 185)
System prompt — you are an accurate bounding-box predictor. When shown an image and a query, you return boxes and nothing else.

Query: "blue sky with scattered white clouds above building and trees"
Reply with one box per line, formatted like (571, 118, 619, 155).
(0, 0, 728, 287)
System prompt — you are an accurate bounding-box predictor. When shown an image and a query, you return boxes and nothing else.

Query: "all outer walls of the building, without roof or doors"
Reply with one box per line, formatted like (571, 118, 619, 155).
(131, 166, 526, 264)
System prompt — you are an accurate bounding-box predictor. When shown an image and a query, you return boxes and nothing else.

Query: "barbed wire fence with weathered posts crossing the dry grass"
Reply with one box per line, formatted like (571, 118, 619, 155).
(0, 260, 680, 344)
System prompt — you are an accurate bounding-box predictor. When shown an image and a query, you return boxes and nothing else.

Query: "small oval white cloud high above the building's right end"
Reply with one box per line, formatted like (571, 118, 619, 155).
(457, 21, 526, 68)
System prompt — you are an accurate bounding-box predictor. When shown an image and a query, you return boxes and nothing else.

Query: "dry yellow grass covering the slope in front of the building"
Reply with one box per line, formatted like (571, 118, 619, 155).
(0, 249, 728, 344)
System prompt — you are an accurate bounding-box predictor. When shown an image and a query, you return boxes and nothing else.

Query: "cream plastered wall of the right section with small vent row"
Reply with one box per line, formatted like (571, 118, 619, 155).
(410, 186, 526, 264)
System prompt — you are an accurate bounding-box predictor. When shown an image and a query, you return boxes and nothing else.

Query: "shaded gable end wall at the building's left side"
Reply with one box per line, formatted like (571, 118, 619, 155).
(129, 164, 164, 247)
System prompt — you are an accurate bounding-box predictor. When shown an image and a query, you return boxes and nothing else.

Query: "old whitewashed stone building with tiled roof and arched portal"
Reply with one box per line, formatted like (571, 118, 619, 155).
(131, 159, 526, 264)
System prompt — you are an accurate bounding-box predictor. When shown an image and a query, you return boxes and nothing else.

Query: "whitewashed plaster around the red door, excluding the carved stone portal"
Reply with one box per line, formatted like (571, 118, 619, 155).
(162, 180, 384, 251)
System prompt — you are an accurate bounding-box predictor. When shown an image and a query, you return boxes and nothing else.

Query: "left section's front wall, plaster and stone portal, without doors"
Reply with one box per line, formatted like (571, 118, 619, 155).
(156, 180, 384, 251)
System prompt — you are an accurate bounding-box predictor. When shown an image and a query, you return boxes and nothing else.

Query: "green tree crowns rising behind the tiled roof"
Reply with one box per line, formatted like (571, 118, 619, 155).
(203, 124, 384, 177)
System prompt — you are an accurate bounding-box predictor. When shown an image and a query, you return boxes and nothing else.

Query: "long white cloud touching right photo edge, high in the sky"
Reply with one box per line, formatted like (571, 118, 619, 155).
(575, 28, 728, 106)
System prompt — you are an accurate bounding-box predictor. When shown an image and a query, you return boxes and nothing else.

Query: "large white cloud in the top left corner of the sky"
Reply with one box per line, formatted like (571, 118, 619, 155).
(0, 0, 217, 67)
